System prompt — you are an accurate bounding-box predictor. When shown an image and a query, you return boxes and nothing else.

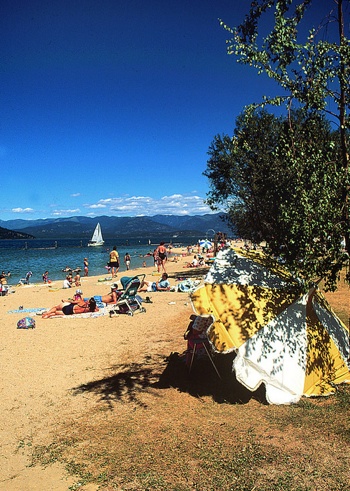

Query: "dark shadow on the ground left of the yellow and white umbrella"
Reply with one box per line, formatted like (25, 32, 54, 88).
(72, 353, 266, 410)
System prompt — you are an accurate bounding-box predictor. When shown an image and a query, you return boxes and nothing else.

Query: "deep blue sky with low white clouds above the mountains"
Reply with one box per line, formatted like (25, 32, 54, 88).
(0, 0, 340, 220)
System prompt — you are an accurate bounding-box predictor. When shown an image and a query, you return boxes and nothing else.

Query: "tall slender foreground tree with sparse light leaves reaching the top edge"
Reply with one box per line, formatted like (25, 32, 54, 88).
(209, 0, 350, 288)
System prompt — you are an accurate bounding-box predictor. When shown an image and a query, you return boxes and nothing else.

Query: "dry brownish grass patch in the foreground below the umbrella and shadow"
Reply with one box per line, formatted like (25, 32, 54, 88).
(33, 387, 350, 491)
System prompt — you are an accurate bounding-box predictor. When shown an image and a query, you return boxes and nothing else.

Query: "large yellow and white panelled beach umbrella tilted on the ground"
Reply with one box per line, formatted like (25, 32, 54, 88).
(192, 249, 350, 404)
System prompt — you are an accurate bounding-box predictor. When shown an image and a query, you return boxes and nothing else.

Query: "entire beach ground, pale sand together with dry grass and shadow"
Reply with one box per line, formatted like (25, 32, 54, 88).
(0, 244, 349, 491)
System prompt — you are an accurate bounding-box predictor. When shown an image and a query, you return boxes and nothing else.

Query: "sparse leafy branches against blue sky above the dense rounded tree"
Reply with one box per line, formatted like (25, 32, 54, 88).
(221, 0, 350, 119)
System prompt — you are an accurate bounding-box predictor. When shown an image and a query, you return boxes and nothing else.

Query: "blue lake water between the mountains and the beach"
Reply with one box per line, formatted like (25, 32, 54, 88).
(0, 237, 198, 285)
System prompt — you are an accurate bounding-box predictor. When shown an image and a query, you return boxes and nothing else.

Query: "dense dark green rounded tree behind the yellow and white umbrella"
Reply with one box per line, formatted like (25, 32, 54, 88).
(204, 109, 346, 289)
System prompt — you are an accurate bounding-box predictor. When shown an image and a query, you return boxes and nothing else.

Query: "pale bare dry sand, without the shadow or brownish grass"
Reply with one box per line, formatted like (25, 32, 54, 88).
(0, 250, 205, 491)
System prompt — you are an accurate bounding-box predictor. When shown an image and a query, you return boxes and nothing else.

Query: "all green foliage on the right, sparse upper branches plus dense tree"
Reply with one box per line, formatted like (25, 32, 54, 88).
(208, 0, 350, 289)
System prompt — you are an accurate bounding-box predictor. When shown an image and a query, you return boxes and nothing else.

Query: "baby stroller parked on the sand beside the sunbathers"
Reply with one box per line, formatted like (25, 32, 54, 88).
(109, 275, 146, 317)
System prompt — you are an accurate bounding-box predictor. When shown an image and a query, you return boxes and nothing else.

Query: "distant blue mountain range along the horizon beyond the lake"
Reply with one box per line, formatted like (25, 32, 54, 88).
(0, 213, 233, 239)
